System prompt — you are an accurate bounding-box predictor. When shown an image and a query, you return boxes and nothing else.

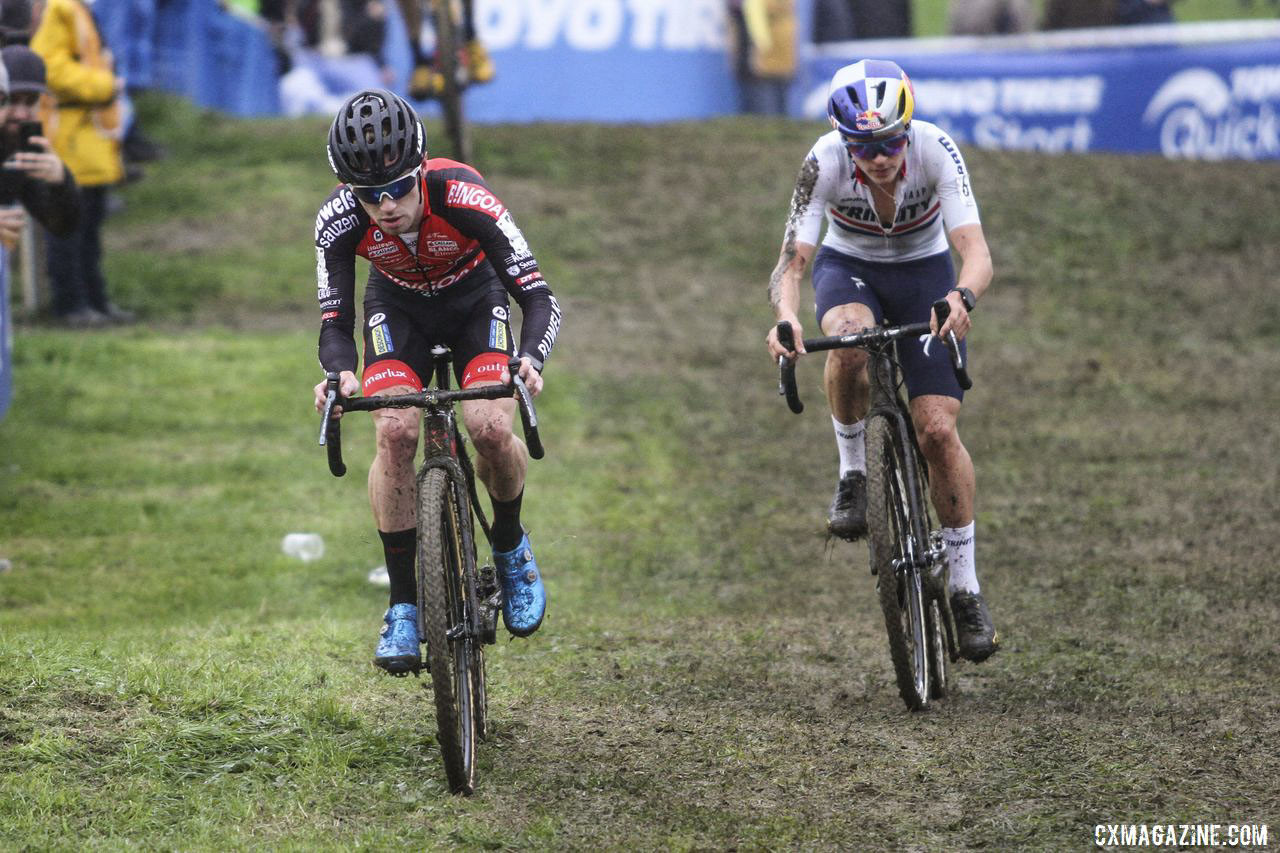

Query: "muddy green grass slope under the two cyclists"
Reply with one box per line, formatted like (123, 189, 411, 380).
(0, 101, 1280, 850)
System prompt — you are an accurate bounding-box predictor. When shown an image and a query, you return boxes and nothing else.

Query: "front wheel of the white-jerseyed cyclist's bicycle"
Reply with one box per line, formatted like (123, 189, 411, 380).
(867, 415, 931, 711)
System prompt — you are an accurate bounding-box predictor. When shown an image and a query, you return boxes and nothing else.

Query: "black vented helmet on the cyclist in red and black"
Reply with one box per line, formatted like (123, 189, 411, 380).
(329, 88, 426, 186)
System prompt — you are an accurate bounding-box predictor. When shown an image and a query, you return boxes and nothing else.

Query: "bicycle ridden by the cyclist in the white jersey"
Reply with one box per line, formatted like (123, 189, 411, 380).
(778, 300, 973, 711)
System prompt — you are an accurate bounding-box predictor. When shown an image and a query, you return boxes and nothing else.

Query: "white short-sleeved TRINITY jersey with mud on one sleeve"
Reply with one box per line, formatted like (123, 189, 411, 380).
(787, 119, 978, 261)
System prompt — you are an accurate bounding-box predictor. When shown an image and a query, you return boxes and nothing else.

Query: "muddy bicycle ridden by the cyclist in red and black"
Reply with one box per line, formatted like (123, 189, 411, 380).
(320, 346, 544, 794)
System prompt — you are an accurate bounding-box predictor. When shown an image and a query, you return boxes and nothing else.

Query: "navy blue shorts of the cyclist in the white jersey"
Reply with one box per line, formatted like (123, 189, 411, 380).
(813, 246, 968, 400)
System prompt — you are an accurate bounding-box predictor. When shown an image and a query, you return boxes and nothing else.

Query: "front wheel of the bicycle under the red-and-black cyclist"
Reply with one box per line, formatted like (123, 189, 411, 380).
(417, 467, 484, 794)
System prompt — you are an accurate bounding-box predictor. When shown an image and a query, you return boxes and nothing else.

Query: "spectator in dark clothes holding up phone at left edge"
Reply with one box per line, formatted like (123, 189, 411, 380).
(0, 45, 79, 297)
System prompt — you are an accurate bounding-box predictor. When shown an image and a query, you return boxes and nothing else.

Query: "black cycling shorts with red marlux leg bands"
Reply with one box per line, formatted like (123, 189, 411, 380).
(364, 268, 516, 397)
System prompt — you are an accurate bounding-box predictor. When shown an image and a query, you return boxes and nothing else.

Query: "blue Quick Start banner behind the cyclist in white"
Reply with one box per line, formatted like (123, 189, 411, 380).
(803, 26, 1280, 160)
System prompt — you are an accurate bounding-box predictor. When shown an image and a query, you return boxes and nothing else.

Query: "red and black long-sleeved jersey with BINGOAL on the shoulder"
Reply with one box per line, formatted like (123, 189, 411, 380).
(315, 159, 561, 370)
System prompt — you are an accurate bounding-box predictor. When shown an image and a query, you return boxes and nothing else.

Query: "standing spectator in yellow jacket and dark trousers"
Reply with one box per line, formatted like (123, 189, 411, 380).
(31, 0, 133, 327)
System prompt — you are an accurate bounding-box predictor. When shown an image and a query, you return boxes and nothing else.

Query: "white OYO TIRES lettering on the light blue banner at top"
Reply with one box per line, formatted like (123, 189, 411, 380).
(476, 0, 727, 51)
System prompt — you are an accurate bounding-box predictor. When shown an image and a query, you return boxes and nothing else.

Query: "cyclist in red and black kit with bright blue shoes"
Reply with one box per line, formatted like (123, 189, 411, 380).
(315, 90, 561, 672)
